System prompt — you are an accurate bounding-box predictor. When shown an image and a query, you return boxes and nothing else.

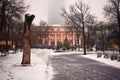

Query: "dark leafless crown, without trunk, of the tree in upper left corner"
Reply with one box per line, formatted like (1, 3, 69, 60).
(0, 0, 29, 31)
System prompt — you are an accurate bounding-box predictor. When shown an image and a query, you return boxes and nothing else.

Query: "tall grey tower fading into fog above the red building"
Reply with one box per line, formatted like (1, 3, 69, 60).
(48, 0, 65, 25)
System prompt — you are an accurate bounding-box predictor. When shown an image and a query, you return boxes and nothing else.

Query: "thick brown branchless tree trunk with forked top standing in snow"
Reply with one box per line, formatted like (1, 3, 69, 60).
(21, 14, 35, 64)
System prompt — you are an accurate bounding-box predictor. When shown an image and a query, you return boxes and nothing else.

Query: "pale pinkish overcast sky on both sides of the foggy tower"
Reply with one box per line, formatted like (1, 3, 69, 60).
(25, 0, 108, 25)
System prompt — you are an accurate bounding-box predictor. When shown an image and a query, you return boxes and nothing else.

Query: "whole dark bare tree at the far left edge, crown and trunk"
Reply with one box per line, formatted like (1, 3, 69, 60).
(0, 0, 27, 51)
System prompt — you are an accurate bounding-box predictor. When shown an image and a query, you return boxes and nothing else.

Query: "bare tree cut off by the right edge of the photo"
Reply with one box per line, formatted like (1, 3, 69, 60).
(104, 0, 120, 52)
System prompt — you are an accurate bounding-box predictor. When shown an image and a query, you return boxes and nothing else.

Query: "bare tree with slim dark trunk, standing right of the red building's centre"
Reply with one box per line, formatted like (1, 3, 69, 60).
(62, 0, 94, 55)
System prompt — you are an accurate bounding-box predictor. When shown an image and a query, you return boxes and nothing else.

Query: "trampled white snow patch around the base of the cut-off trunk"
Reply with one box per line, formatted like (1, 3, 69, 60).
(0, 49, 53, 80)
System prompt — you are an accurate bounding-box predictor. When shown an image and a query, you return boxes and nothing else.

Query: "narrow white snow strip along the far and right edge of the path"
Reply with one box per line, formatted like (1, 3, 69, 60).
(51, 51, 120, 68)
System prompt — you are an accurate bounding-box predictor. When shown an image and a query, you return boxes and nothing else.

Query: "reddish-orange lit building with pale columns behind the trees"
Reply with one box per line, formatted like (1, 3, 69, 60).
(38, 25, 82, 47)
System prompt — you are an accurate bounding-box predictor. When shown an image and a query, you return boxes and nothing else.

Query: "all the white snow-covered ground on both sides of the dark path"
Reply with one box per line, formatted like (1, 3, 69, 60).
(0, 49, 120, 80)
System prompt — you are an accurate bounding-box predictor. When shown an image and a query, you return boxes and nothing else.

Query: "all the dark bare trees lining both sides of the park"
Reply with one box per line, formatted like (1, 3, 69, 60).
(0, 0, 120, 54)
